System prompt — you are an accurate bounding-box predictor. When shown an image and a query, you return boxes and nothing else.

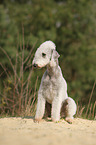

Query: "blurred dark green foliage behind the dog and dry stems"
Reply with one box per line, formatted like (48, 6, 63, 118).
(0, 0, 96, 115)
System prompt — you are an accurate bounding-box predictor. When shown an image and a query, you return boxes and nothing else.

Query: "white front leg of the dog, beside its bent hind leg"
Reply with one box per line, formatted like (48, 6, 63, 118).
(51, 97, 61, 122)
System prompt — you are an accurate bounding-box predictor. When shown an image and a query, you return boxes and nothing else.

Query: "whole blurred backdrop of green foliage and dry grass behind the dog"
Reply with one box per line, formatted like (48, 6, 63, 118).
(0, 0, 96, 117)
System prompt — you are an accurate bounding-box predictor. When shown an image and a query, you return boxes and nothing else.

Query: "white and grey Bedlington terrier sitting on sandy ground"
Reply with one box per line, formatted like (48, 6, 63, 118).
(32, 41, 76, 123)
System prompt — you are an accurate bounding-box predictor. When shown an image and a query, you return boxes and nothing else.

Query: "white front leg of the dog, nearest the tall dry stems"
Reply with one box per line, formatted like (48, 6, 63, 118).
(35, 95, 45, 122)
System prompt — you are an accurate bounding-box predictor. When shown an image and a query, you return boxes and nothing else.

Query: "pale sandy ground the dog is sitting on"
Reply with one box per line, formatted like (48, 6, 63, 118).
(0, 117, 96, 145)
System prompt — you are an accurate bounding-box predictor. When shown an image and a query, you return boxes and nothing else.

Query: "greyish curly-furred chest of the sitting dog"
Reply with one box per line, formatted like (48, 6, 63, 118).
(42, 75, 58, 103)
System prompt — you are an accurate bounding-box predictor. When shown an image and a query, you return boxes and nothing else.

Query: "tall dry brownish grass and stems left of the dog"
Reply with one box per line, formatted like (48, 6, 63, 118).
(0, 28, 38, 116)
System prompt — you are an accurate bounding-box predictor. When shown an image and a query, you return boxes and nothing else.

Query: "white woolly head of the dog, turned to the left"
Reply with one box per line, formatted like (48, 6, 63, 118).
(32, 41, 59, 68)
